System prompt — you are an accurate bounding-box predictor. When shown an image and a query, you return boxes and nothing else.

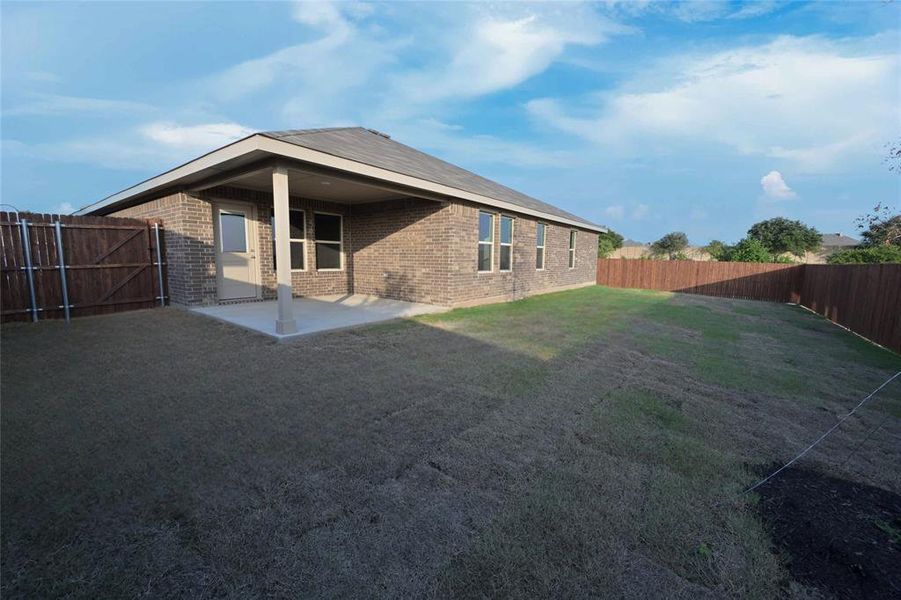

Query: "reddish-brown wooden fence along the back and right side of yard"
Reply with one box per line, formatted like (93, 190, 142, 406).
(597, 258, 901, 352)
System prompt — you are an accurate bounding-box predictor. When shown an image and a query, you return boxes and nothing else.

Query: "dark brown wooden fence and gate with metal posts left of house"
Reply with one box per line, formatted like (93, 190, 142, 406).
(0, 212, 168, 321)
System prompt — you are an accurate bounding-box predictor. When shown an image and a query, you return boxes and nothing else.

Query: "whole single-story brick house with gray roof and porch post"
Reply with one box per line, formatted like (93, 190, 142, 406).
(77, 127, 605, 332)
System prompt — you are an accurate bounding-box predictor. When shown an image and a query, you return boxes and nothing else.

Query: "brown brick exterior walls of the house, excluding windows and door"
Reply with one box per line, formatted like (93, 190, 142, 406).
(112, 187, 597, 306)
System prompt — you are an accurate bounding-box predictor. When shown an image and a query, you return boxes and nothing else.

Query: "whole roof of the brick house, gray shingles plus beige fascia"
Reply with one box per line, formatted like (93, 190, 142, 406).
(76, 127, 606, 231)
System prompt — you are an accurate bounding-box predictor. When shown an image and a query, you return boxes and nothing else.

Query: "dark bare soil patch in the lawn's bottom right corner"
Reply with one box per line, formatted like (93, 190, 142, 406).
(759, 469, 901, 598)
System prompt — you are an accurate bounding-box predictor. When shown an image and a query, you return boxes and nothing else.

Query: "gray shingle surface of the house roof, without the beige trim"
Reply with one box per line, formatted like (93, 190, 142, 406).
(260, 127, 597, 227)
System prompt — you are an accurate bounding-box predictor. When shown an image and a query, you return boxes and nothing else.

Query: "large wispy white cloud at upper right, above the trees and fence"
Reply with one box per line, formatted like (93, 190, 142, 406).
(527, 37, 901, 172)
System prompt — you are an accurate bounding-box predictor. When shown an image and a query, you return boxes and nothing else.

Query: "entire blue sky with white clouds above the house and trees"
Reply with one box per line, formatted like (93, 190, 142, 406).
(0, 1, 901, 243)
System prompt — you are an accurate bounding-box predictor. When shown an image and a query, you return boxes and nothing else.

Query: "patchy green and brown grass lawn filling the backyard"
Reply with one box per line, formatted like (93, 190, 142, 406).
(0, 287, 901, 598)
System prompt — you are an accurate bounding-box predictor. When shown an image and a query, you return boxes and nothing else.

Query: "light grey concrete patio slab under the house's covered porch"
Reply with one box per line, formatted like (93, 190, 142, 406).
(191, 294, 450, 340)
